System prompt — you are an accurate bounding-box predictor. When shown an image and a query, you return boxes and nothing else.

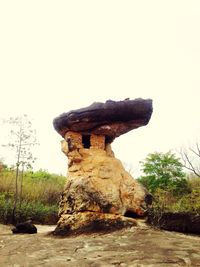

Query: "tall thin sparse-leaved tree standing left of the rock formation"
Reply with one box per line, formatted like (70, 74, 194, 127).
(4, 115, 37, 223)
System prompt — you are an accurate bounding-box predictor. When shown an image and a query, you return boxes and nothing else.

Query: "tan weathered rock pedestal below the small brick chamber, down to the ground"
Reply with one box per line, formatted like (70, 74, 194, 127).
(55, 148, 147, 235)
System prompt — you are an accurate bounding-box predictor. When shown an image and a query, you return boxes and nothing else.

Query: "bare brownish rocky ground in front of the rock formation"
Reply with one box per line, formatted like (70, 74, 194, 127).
(0, 223, 200, 267)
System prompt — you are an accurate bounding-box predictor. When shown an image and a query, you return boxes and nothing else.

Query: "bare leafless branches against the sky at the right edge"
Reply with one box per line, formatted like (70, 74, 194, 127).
(180, 142, 200, 177)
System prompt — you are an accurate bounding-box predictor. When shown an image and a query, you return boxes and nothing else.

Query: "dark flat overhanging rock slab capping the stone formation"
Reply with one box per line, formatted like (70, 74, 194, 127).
(53, 98, 153, 140)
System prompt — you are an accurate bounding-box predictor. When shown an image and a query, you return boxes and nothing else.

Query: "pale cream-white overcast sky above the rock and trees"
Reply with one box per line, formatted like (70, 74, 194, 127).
(0, 0, 200, 178)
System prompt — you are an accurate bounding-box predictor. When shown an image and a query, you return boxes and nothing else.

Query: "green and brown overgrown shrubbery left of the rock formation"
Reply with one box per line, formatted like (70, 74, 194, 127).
(0, 167, 66, 224)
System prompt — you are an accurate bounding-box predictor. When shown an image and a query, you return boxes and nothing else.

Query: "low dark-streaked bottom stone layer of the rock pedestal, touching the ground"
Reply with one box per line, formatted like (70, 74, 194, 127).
(54, 211, 137, 236)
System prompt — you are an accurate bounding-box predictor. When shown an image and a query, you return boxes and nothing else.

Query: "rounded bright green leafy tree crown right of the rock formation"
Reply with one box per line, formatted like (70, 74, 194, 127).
(139, 152, 189, 194)
